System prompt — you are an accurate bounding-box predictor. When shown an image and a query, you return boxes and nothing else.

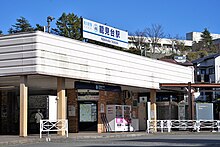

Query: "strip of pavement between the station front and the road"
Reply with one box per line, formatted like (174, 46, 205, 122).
(0, 131, 220, 147)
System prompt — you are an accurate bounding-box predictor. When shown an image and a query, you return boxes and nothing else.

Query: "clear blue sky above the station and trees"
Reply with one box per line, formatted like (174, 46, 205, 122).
(0, 0, 220, 38)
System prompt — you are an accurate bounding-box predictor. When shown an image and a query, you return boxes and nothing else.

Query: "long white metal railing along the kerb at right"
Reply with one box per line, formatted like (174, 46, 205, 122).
(146, 120, 220, 133)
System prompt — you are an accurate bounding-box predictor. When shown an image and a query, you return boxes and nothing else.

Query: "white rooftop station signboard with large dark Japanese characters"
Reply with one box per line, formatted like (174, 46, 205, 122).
(82, 18, 128, 48)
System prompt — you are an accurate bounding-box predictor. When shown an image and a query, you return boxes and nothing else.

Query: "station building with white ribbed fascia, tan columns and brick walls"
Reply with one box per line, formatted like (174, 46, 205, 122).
(0, 31, 194, 137)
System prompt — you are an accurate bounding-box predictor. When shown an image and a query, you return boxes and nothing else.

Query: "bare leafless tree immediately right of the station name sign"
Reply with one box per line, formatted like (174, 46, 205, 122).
(129, 30, 147, 55)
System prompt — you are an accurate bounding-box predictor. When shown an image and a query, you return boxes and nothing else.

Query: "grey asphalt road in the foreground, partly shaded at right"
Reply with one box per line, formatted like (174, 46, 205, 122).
(4, 133, 220, 147)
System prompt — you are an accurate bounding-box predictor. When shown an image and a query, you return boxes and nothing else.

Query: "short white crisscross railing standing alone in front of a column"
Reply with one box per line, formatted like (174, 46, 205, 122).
(40, 119, 68, 138)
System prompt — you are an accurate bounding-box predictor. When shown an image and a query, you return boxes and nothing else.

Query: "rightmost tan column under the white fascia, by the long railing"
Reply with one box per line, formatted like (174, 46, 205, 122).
(150, 89, 157, 132)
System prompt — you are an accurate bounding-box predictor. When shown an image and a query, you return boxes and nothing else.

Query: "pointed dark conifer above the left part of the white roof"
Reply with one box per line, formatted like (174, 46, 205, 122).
(8, 16, 34, 34)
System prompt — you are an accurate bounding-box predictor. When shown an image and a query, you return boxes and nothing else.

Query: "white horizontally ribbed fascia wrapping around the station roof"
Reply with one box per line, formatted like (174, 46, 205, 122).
(0, 32, 193, 89)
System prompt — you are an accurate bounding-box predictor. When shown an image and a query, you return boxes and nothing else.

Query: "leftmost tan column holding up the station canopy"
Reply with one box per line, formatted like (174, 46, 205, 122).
(19, 76, 28, 137)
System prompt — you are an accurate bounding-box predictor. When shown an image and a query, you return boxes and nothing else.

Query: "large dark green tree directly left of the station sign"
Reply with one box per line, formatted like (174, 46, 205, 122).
(53, 13, 82, 40)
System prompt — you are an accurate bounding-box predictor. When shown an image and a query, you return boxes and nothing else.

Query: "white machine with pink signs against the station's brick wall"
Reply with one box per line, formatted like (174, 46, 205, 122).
(106, 105, 134, 131)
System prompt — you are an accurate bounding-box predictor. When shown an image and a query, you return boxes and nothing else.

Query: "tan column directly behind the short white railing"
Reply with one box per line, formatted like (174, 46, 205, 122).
(57, 78, 67, 136)
